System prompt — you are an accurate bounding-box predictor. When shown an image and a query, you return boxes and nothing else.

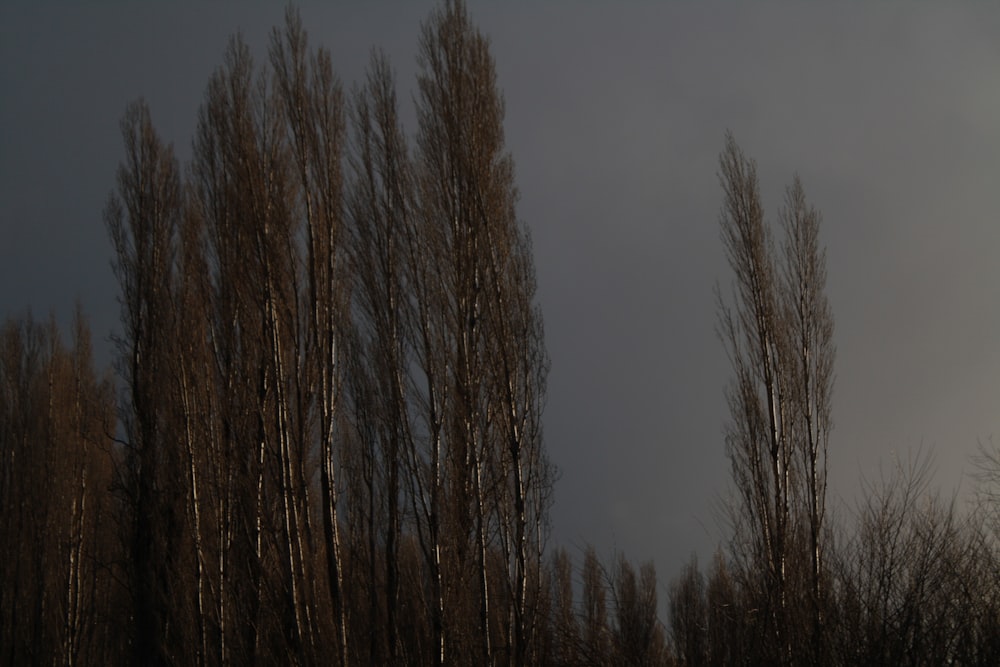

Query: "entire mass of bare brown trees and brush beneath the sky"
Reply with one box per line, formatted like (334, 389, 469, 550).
(0, 0, 1000, 665)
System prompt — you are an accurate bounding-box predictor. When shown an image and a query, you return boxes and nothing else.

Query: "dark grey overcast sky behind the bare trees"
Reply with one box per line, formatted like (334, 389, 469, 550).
(0, 2, 1000, 581)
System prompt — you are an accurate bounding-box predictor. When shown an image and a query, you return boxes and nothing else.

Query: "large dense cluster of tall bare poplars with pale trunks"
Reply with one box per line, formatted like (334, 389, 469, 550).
(106, 2, 552, 664)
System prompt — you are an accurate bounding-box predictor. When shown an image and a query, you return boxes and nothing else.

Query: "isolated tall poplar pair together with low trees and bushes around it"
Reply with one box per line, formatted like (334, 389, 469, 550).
(669, 134, 1000, 665)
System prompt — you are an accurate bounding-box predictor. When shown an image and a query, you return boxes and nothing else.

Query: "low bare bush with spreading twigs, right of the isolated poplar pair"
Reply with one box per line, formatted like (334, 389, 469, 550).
(832, 454, 997, 665)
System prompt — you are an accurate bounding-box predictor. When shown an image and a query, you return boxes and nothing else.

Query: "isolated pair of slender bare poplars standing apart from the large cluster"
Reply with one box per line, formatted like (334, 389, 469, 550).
(718, 134, 834, 663)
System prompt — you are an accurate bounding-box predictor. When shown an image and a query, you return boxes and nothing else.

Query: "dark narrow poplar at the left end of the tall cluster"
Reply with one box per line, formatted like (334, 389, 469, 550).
(105, 102, 188, 664)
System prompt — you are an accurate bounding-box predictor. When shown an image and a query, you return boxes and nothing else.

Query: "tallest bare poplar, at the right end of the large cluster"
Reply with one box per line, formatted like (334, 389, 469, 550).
(413, 2, 552, 663)
